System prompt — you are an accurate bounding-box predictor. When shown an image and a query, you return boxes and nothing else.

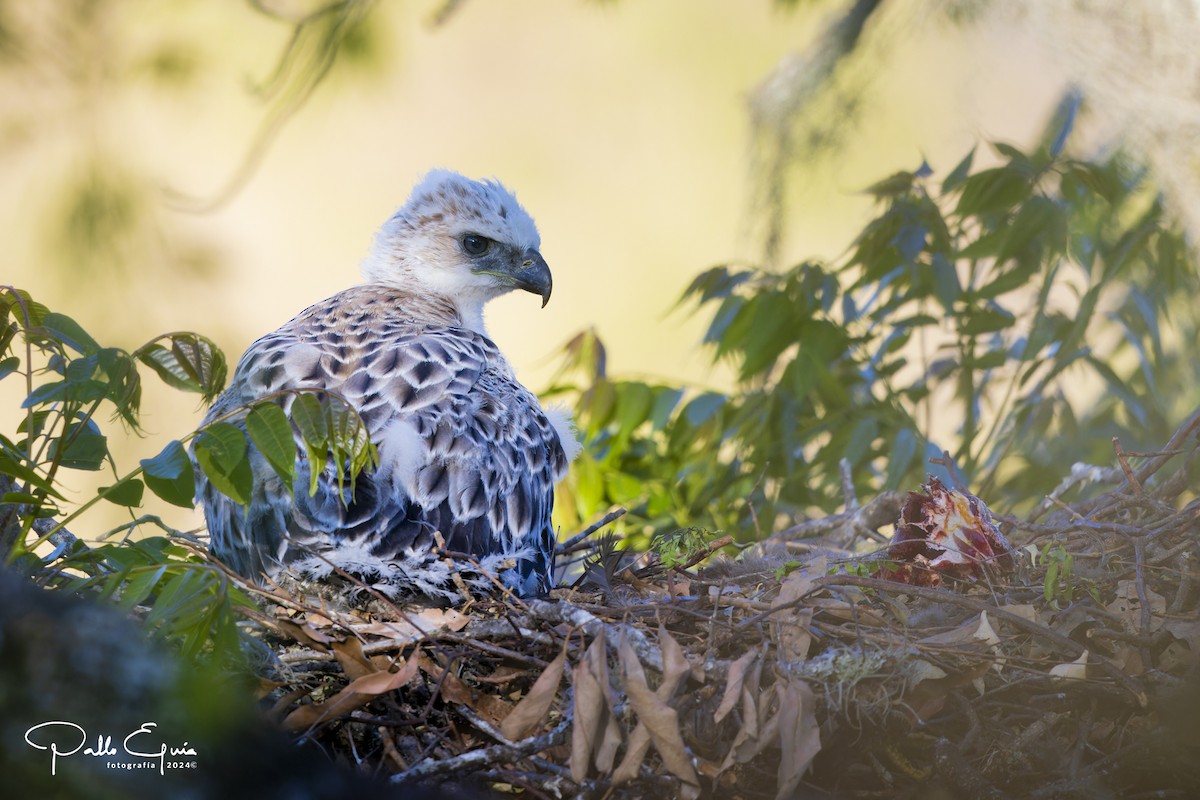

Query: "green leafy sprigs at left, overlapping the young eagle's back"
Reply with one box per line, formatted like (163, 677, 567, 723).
(0, 287, 376, 662)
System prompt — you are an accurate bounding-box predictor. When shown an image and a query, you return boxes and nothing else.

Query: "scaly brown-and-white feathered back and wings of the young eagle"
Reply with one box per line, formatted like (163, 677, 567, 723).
(198, 287, 566, 594)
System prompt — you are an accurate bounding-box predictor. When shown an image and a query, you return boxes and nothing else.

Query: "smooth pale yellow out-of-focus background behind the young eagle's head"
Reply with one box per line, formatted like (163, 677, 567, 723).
(0, 0, 1063, 537)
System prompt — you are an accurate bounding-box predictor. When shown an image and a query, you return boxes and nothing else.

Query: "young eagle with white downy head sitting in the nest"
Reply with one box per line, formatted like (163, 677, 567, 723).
(197, 170, 578, 600)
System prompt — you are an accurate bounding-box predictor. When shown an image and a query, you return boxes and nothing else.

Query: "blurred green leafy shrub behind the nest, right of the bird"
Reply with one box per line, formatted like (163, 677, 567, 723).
(548, 120, 1200, 540)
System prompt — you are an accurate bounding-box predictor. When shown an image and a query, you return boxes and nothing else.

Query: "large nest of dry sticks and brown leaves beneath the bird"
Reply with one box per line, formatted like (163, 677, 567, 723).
(231, 414, 1200, 799)
